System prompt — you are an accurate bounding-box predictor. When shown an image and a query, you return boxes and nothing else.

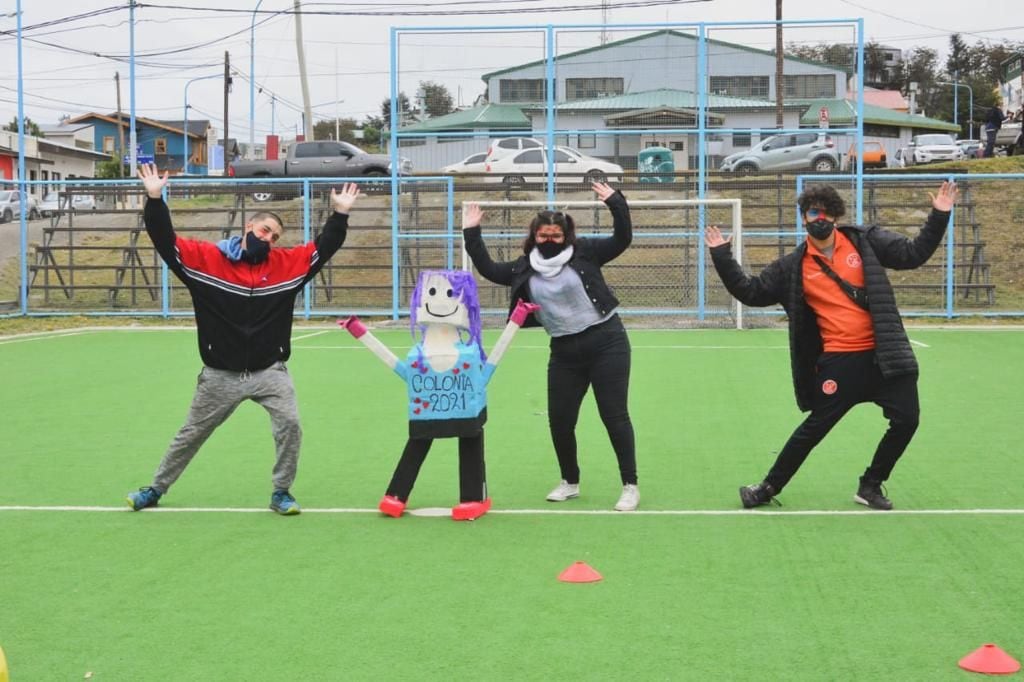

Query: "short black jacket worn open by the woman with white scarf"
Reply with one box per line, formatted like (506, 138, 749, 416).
(463, 191, 633, 327)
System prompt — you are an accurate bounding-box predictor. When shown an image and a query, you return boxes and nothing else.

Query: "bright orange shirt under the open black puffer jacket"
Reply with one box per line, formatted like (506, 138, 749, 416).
(803, 229, 874, 352)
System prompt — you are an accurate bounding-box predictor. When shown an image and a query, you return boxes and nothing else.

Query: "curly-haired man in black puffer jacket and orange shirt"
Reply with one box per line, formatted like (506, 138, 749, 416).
(705, 182, 957, 509)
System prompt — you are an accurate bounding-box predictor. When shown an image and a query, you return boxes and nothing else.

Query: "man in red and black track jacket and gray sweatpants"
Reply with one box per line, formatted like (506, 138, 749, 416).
(128, 166, 361, 514)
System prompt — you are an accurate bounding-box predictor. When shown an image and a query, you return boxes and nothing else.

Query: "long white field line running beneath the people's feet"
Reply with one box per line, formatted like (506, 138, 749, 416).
(0, 505, 1024, 518)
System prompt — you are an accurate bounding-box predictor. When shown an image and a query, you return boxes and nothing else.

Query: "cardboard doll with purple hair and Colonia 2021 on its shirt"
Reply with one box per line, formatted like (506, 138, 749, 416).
(339, 270, 537, 521)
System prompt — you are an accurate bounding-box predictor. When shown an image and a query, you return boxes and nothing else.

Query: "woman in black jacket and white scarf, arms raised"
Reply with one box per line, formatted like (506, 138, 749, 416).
(463, 182, 640, 511)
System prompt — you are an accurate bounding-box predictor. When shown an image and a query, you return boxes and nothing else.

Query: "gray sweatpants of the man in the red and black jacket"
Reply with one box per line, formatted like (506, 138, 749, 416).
(153, 363, 302, 493)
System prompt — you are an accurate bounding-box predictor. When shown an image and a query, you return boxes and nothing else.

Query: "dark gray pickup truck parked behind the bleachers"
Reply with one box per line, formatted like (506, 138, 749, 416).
(227, 140, 413, 202)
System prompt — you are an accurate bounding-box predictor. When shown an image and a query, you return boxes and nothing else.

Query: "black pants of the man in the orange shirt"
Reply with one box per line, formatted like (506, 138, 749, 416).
(765, 350, 921, 493)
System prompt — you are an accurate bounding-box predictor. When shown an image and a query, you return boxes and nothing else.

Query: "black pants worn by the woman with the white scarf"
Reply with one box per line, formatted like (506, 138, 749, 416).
(548, 315, 637, 484)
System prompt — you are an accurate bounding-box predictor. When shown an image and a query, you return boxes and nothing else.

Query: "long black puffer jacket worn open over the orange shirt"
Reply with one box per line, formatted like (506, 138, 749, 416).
(711, 209, 949, 411)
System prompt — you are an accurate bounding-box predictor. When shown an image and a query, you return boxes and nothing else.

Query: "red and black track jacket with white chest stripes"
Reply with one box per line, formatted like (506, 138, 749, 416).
(143, 199, 348, 372)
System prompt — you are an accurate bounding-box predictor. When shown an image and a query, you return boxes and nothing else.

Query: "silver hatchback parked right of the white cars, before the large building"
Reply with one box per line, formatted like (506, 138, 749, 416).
(720, 133, 840, 173)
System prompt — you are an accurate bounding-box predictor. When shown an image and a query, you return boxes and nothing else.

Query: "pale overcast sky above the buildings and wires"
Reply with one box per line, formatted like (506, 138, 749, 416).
(0, 0, 1024, 139)
